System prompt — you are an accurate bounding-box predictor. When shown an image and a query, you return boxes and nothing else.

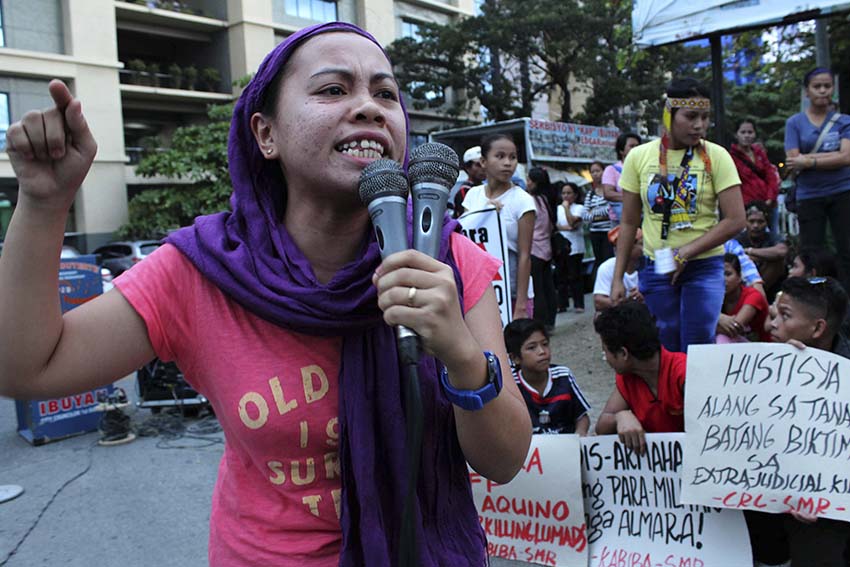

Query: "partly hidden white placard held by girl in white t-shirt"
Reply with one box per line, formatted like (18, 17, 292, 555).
(458, 208, 513, 327)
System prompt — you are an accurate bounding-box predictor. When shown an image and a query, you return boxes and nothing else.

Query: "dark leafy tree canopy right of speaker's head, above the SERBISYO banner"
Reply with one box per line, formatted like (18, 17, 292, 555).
(389, 0, 707, 127)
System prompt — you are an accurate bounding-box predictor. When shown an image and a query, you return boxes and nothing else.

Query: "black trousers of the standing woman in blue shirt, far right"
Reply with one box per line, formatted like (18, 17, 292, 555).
(797, 191, 850, 291)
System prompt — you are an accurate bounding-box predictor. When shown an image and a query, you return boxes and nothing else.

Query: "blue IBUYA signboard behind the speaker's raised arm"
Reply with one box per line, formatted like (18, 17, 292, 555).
(15, 255, 114, 445)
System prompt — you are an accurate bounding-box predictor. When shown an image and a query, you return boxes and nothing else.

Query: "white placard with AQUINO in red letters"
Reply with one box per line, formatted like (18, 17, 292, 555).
(470, 435, 587, 567)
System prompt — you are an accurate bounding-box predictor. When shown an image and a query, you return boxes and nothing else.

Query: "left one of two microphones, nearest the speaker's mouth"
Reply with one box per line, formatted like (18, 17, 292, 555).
(360, 159, 419, 364)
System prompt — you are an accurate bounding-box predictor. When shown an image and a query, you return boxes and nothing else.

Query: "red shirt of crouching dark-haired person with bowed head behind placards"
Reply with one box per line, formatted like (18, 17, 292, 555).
(617, 347, 687, 433)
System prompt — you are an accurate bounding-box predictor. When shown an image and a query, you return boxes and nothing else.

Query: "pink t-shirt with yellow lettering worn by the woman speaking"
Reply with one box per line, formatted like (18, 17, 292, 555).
(115, 234, 499, 567)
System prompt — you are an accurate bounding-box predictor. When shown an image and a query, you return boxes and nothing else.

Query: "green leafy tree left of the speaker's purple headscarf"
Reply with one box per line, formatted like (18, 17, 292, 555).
(117, 104, 233, 239)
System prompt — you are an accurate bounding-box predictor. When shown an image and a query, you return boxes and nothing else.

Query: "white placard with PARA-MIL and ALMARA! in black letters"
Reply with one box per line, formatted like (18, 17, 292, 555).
(581, 433, 752, 567)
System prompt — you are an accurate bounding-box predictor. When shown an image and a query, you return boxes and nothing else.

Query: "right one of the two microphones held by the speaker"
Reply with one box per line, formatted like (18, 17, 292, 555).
(407, 143, 460, 258)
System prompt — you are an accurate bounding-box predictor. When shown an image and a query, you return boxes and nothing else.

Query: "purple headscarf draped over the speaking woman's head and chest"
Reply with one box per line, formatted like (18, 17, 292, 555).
(166, 22, 487, 567)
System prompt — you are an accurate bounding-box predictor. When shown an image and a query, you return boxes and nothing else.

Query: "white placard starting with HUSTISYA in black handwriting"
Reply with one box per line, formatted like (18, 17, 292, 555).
(682, 343, 850, 521)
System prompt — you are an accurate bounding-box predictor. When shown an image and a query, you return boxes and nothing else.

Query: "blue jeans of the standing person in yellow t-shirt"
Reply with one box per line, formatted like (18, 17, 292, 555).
(639, 256, 726, 352)
